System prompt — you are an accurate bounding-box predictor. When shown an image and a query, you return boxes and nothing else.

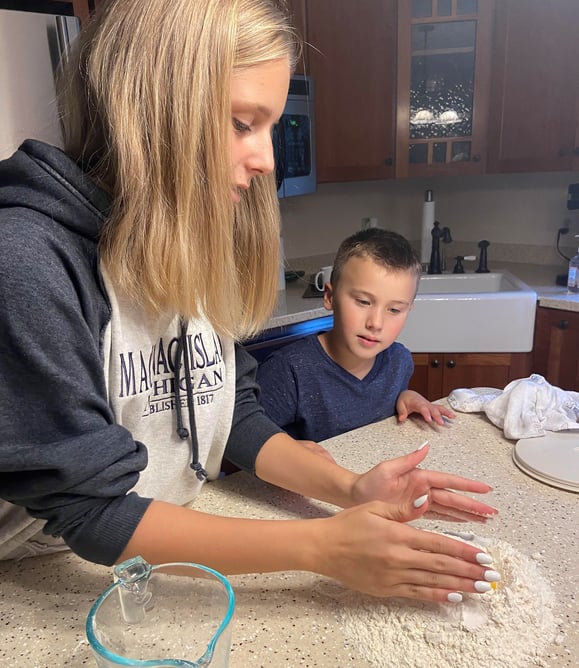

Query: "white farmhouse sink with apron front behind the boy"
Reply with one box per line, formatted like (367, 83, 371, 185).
(398, 271, 537, 353)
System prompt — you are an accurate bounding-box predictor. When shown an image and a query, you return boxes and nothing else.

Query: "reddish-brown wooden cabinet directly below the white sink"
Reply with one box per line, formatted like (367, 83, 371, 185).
(409, 353, 532, 401)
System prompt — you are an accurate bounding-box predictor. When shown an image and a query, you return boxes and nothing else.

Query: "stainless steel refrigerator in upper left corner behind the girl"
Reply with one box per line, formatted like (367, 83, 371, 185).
(0, 9, 80, 159)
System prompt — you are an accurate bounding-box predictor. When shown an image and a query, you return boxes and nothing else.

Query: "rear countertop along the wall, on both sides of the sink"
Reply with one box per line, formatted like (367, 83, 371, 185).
(268, 256, 579, 328)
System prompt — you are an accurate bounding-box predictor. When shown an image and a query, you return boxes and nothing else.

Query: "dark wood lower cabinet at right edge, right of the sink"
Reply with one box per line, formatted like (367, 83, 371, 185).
(533, 306, 579, 392)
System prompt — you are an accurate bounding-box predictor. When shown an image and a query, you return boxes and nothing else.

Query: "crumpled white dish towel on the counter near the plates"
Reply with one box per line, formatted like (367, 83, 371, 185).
(448, 373, 579, 440)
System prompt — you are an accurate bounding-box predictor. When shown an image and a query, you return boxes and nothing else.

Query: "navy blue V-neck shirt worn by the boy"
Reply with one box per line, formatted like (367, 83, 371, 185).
(257, 334, 414, 441)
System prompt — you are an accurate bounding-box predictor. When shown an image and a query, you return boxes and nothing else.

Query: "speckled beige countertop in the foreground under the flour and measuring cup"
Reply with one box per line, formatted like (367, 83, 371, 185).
(0, 414, 579, 668)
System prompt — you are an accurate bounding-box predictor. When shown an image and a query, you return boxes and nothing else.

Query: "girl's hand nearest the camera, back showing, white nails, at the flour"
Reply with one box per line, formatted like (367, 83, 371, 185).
(312, 501, 500, 603)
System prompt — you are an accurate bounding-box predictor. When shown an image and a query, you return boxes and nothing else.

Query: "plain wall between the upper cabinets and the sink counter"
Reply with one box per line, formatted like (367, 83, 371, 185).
(281, 172, 579, 264)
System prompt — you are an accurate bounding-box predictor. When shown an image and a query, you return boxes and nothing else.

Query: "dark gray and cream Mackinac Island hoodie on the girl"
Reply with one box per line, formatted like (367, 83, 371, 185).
(0, 141, 281, 565)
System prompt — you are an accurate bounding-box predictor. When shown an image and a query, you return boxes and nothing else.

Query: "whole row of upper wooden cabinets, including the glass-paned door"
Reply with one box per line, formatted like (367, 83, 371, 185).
(302, 0, 579, 182)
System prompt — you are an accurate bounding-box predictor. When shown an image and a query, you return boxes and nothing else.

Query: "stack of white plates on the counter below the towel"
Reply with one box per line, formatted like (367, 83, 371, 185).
(513, 429, 579, 492)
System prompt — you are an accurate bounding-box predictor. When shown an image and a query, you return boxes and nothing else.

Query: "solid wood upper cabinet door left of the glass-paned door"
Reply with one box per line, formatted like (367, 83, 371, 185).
(306, 0, 396, 182)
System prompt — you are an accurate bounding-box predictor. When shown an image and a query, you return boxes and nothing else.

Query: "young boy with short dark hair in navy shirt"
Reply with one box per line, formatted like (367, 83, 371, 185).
(258, 228, 455, 441)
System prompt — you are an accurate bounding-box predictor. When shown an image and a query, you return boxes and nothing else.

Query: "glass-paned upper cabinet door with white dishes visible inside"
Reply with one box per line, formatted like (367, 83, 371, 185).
(396, 0, 494, 177)
